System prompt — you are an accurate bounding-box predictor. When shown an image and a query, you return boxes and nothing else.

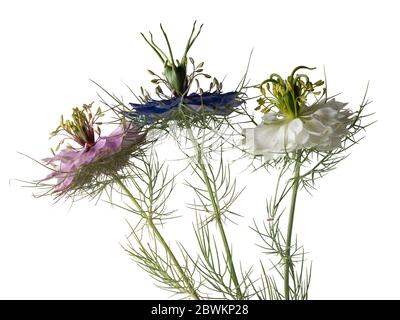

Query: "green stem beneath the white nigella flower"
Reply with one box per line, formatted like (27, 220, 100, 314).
(283, 151, 301, 300)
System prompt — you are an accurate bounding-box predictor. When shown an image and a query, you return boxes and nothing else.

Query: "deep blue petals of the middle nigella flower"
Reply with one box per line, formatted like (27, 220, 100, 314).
(128, 91, 244, 120)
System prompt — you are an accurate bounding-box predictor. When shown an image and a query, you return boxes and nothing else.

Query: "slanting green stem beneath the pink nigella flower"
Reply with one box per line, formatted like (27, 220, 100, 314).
(114, 176, 200, 300)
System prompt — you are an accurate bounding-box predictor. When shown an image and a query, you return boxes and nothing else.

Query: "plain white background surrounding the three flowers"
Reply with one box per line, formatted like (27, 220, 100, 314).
(0, 0, 400, 299)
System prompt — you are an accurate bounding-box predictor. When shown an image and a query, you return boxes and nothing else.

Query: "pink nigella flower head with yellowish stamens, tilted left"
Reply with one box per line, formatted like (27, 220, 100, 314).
(41, 104, 146, 195)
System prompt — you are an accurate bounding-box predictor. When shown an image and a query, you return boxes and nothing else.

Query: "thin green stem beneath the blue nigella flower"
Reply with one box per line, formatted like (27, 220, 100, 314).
(187, 126, 243, 299)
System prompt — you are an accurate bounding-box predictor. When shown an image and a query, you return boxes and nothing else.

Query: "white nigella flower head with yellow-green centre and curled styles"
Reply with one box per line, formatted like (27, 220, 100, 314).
(245, 67, 353, 161)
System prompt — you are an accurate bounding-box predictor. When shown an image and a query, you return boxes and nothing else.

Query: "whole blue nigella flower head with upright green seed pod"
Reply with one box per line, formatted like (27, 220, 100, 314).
(124, 22, 244, 126)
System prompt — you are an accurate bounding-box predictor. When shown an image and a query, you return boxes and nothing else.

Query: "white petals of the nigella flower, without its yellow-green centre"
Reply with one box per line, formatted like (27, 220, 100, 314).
(245, 99, 353, 161)
